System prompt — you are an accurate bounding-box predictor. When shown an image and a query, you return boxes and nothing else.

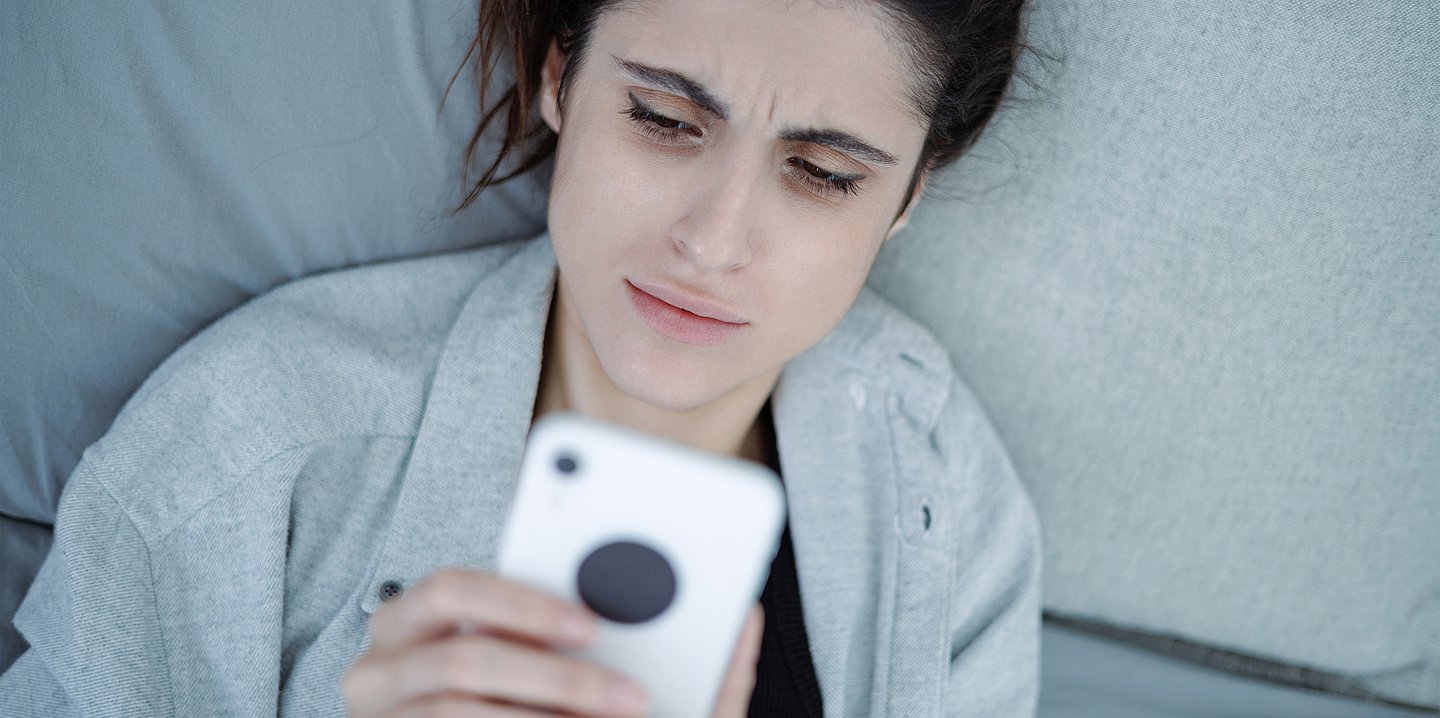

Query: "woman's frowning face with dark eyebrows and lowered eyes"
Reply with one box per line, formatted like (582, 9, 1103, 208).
(540, 0, 926, 412)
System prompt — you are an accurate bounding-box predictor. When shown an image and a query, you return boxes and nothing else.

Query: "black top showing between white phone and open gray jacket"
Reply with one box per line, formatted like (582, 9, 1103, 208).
(747, 521, 822, 718)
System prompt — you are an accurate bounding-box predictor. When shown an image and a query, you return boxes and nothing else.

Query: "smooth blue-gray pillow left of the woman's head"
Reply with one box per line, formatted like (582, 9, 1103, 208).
(0, 0, 544, 522)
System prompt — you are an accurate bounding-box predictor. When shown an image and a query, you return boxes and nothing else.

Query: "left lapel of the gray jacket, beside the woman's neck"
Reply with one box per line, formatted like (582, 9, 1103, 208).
(361, 235, 554, 613)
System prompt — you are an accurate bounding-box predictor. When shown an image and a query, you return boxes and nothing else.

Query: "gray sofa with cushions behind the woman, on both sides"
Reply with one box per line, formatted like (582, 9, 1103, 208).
(0, 0, 1440, 717)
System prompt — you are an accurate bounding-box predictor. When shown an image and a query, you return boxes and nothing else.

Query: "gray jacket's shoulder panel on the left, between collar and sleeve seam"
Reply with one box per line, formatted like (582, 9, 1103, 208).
(76, 242, 541, 530)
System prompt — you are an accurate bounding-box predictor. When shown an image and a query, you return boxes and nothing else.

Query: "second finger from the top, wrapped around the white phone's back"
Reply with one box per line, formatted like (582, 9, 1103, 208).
(343, 636, 645, 717)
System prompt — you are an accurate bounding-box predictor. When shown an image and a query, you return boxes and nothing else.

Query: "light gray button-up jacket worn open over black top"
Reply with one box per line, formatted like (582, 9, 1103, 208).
(0, 235, 1040, 718)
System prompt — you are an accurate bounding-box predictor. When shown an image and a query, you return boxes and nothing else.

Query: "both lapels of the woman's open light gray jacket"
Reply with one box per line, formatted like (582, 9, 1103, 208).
(361, 235, 949, 705)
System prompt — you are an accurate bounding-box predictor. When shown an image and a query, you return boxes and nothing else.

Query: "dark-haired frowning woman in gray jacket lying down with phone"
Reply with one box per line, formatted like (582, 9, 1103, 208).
(0, 0, 1040, 717)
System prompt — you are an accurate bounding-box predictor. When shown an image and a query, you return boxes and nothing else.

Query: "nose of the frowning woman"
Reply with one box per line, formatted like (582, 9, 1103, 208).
(671, 151, 763, 272)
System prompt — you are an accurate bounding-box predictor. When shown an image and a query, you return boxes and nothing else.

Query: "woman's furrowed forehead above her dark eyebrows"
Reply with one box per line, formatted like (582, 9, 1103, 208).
(586, 0, 924, 142)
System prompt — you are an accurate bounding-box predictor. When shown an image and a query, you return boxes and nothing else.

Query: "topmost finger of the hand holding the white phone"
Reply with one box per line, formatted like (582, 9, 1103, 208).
(370, 568, 596, 650)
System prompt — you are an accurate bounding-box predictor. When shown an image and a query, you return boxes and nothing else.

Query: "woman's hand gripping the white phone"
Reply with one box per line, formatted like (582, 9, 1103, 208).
(341, 570, 650, 718)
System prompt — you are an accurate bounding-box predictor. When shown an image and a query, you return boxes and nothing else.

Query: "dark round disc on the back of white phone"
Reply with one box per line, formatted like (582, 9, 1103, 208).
(576, 541, 675, 623)
